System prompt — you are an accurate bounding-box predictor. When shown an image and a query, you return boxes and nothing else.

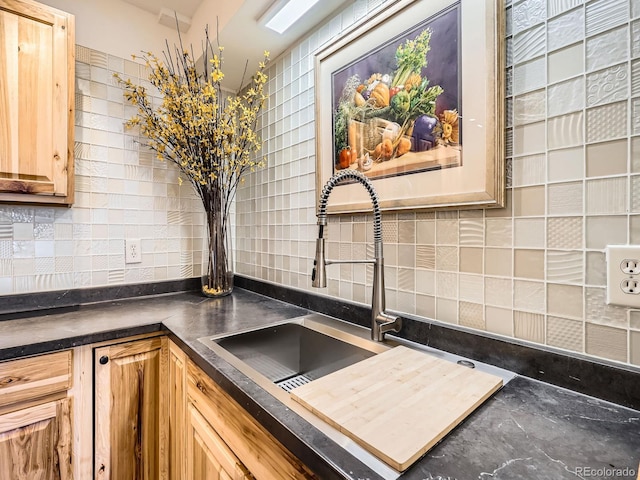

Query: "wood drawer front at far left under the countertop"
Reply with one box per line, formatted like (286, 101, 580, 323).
(0, 350, 72, 407)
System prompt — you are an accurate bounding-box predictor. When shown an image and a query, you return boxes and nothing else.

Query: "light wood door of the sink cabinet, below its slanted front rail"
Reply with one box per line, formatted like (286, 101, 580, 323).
(186, 403, 253, 480)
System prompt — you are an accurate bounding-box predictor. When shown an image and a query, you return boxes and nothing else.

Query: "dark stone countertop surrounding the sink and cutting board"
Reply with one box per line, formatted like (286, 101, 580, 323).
(0, 288, 640, 480)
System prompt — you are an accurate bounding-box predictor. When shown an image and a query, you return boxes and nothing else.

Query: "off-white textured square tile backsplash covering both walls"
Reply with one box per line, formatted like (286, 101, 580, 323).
(0, 0, 640, 363)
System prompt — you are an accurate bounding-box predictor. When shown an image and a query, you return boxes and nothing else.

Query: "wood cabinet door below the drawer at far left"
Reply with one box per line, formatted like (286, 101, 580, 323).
(0, 398, 73, 480)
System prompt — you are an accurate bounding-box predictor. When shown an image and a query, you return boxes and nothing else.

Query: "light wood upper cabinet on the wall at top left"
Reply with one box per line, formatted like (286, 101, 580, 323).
(0, 0, 75, 205)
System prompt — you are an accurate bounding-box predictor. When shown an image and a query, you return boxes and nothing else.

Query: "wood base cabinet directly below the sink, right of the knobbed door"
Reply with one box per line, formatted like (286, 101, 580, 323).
(169, 338, 317, 480)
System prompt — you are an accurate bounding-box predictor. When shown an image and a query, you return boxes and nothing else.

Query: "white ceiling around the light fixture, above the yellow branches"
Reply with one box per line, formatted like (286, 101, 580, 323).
(125, 0, 355, 91)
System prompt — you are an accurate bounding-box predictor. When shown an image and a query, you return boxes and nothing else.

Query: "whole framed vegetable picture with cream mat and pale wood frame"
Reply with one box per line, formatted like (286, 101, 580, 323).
(315, 0, 505, 213)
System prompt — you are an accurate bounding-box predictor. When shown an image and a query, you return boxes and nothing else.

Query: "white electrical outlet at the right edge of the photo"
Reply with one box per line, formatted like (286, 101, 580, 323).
(606, 245, 640, 308)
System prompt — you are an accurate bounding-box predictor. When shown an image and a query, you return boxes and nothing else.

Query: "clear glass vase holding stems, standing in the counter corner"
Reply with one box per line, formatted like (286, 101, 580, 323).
(201, 211, 233, 297)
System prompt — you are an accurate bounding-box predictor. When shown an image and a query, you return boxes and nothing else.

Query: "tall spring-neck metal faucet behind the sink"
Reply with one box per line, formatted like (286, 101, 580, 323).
(311, 169, 402, 342)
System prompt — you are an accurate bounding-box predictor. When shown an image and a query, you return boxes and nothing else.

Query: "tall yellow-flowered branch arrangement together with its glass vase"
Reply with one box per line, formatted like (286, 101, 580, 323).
(115, 29, 269, 297)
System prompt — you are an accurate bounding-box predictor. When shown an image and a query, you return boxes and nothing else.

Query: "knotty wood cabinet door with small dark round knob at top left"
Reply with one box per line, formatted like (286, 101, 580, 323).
(94, 337, 169, 480)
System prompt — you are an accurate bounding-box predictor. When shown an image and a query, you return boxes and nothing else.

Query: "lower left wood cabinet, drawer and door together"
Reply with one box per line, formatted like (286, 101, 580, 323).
(0, 350, 73, 480)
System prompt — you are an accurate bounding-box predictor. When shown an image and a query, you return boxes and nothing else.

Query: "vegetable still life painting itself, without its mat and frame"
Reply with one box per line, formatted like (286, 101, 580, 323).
(332, 4, 462, 178)
